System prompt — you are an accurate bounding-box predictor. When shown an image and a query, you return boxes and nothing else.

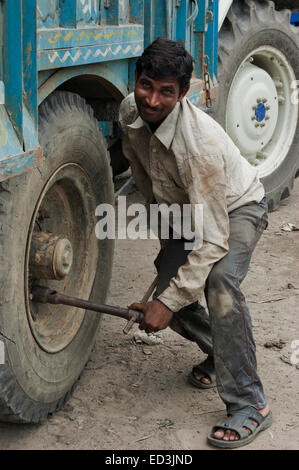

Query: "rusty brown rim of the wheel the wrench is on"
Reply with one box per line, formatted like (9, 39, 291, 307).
(25, 163, 98, 353)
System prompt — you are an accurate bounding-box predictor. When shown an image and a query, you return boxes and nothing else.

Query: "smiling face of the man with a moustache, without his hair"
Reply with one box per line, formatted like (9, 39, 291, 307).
(135, 72, 188, 128)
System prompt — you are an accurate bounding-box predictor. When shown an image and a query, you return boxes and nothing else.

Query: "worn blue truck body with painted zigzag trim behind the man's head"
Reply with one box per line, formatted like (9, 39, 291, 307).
(0, 0, 218, 181)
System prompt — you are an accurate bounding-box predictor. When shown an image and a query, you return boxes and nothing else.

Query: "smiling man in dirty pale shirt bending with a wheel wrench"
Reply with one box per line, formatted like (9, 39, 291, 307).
(120, 38, 272, 447)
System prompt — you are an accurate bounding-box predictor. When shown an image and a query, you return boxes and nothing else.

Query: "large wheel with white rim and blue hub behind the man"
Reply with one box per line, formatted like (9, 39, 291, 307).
(212, 0, 299, 210)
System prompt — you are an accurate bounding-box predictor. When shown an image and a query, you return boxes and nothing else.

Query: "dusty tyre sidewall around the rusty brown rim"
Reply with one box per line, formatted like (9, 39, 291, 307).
(1, 100, 113, 402)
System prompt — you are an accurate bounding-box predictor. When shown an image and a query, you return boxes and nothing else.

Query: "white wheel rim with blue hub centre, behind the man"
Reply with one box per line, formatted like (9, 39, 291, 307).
(226, 46, 299, 178)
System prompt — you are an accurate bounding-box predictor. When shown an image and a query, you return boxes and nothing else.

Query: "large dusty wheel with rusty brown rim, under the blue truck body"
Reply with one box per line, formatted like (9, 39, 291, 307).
(0, 92, 114, 423)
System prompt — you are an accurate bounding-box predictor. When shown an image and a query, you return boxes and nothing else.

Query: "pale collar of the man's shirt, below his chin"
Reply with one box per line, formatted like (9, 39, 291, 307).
(128, 102, 180, 149)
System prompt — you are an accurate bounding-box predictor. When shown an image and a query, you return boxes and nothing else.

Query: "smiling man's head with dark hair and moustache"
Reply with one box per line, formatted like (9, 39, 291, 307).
(135, 38, 193, 127)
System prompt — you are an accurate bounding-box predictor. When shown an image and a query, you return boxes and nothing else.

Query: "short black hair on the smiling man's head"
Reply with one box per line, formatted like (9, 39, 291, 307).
(136, 38, 193, 91)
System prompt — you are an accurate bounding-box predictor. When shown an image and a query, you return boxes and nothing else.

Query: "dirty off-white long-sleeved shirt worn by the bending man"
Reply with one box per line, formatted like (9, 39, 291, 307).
(119, 93, 265, 312)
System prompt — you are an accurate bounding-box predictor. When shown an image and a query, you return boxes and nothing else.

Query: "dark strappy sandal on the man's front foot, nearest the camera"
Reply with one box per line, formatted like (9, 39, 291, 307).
(208, 406, 272, 449)
